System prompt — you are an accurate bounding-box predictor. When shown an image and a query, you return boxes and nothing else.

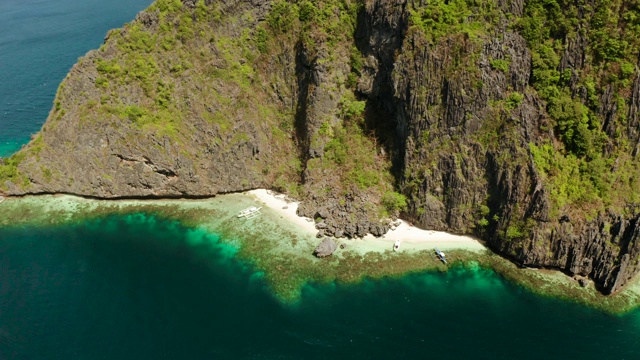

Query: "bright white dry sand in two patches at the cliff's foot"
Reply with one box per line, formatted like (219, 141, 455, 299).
(247, 189, 486, 253)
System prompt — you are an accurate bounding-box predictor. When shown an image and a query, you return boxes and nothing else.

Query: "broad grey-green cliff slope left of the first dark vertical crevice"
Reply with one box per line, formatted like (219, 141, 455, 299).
(7, 1, 296, 198)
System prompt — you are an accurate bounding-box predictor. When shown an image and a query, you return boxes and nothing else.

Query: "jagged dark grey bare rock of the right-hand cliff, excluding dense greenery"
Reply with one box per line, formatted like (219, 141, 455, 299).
(344, 1, 640, 293)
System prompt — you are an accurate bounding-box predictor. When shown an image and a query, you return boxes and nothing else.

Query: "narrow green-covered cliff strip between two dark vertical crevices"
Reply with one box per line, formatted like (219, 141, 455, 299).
(257, 0, 400, 220)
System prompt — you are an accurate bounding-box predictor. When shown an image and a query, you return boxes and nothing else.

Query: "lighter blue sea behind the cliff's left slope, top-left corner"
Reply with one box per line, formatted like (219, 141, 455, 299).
(0, 0, 151, 157)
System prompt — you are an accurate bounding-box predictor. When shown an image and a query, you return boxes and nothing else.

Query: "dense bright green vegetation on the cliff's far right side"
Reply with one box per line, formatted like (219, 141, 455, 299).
(518, 0, 640, 218)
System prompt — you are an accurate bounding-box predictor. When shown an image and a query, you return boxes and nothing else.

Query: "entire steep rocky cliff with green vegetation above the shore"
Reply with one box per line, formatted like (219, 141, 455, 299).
(0, 0, 640, 292)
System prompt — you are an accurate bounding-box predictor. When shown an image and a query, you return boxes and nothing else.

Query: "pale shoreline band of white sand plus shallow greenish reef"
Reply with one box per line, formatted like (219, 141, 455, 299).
(5, 190, 640, 313)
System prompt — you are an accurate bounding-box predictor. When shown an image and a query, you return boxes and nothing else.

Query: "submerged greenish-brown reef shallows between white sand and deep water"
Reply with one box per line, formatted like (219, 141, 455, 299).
(0, 194, 640, 313)
